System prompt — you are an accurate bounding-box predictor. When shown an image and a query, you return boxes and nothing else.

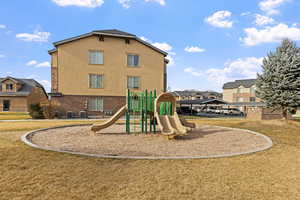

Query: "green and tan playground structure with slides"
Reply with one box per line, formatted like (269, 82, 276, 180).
(91, 90, 195, 139)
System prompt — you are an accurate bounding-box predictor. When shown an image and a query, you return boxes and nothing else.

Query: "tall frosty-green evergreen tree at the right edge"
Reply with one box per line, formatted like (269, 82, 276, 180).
(256, 39, 300, 119)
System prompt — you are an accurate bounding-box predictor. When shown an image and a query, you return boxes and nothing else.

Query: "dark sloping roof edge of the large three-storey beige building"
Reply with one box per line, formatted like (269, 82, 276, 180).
(48, 31, 168, 56)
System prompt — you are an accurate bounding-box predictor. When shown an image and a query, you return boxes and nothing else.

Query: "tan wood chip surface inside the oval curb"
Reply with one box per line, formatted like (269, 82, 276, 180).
(27, 125, 272, 159)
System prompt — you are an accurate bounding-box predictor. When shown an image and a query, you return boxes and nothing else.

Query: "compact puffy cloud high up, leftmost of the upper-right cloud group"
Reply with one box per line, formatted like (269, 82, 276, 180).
(205, 10, 233, 28)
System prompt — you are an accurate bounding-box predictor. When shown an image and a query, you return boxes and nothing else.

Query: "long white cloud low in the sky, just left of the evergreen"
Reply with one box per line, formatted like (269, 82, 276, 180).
(184, 57, 263, 86)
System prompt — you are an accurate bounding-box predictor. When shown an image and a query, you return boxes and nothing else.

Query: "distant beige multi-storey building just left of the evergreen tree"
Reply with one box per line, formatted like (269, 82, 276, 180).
(223, 79, 261, 103)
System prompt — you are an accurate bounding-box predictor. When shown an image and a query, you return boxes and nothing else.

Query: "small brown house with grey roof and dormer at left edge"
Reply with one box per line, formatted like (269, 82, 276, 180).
(0, 77, 48, 112)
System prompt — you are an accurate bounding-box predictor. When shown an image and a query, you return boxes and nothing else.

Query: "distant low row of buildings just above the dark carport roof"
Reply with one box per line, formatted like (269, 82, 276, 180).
(172, 90, 222, 101)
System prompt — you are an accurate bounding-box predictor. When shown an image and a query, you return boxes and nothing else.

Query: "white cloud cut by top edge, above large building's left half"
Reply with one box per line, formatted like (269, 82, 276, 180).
(52, 0, 104, 8)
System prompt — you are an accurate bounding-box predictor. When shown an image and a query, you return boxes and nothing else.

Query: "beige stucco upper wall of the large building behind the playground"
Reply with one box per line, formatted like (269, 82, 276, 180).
(52, 36, 164, 96)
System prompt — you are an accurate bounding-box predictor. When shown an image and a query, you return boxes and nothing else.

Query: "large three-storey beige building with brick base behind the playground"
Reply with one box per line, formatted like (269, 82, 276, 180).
(49, 30, 168, 115)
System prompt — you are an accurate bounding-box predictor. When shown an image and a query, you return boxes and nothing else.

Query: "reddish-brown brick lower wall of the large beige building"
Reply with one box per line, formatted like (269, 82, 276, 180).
(51, 95, 126, 115)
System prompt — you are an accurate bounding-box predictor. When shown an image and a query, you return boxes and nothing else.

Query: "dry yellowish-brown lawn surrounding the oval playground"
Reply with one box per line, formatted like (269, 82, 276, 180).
(0, 119, 300, 200)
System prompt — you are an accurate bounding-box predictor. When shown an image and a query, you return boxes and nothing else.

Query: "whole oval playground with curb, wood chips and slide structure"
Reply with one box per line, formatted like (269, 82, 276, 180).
(22, 90, 273, 159)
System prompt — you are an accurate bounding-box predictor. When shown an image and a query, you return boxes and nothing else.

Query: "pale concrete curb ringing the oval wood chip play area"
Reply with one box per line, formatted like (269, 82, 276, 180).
(21, 124, 273, 160)
